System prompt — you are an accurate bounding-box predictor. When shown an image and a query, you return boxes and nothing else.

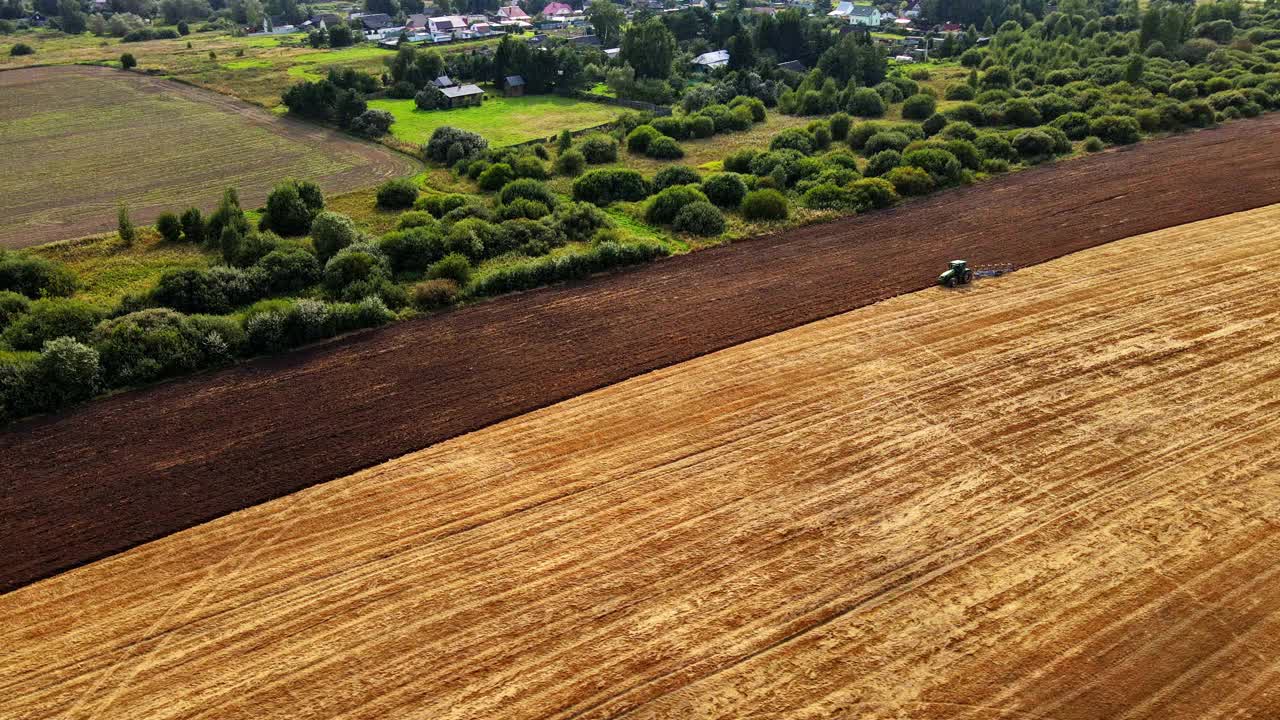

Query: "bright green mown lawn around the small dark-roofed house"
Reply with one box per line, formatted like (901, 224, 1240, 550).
(369, 95, 622, 147)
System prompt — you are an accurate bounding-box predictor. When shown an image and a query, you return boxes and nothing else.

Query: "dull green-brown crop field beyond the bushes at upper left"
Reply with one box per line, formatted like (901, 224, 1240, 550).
(0, 67, 417, 246)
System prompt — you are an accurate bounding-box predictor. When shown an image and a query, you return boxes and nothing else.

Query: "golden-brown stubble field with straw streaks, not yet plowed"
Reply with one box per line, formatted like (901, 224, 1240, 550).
(0, 208, 1280, 720)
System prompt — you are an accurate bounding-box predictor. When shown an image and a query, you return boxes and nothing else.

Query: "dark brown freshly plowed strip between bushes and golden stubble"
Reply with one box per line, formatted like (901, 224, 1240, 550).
(0, 115, 1280, 589)
